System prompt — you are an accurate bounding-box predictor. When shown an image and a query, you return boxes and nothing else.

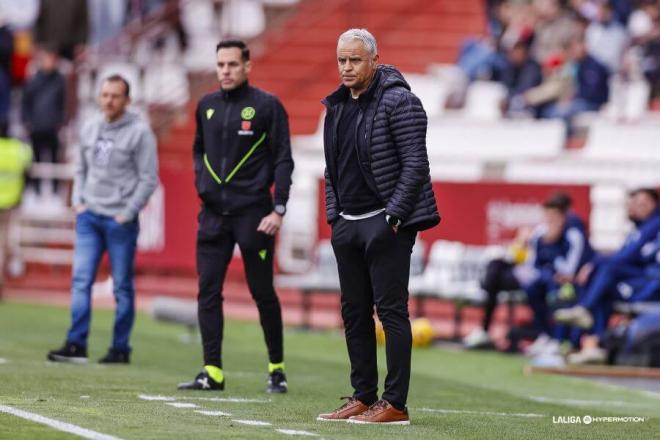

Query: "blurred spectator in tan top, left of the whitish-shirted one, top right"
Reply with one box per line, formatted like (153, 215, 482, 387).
(531, 0, 578, 64)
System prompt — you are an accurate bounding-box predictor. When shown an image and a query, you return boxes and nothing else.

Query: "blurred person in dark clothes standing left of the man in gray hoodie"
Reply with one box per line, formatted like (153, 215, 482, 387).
(21, 47, 66, 194)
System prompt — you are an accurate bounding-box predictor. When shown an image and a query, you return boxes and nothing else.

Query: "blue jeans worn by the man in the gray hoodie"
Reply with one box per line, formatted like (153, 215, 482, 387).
(67, 211, 139, 352)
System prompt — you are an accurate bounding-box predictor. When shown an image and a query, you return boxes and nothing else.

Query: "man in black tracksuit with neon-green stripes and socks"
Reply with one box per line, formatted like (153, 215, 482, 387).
(179, 40, 293, 393)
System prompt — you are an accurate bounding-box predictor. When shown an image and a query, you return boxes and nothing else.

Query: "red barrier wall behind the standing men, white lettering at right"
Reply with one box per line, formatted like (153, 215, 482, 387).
(137, 174, 590, 273)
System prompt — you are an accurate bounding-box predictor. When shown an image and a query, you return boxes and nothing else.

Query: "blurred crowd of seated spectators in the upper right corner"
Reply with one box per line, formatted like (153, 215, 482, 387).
(458, 0, 660, 134)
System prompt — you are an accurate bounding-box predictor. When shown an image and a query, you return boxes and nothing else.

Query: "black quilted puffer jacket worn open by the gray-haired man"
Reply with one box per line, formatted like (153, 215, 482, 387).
(322, 65, 440, 230)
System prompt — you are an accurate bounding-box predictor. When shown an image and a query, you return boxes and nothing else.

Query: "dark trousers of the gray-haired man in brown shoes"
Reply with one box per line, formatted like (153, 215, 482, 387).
(332, 214, 415, 408)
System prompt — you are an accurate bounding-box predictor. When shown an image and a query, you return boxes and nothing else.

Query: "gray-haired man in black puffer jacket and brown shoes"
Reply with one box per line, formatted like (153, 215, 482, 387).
(318, 29, 440, 425)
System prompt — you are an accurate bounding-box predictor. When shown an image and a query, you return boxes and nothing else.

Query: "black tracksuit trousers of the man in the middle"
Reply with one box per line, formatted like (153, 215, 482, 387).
(197, 208, 284, 368)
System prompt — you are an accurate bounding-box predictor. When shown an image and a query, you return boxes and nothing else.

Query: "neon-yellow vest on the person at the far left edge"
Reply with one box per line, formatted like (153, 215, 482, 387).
(0, 138, 32, 209)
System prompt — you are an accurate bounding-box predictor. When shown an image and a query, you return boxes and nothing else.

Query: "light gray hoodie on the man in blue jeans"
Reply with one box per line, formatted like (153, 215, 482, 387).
(72, 111, 158, 220)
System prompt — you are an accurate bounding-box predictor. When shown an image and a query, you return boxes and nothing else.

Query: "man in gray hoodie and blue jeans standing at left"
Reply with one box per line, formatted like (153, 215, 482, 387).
(48, 75, 158, 363)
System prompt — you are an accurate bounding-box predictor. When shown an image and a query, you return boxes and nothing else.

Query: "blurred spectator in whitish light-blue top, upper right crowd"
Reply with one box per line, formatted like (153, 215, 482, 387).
(584, 1, 628, 74)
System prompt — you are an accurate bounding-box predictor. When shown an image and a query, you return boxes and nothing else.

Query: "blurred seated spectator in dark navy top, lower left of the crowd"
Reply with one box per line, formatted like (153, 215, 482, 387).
(493, 41, 542, 116)
